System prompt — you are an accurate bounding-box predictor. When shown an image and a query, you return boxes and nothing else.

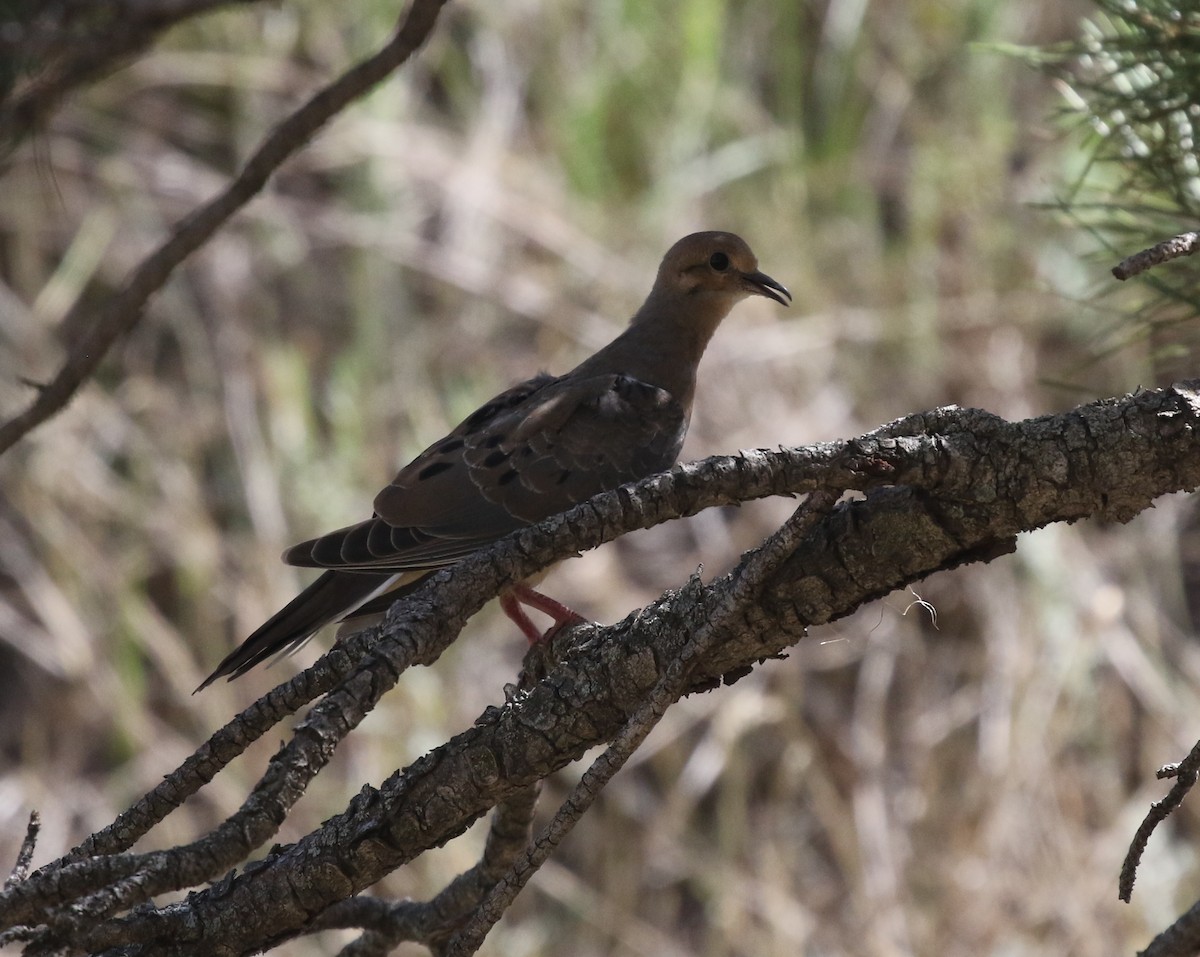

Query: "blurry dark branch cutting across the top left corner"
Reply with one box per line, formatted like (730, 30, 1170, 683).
(0, 0, 259, 152)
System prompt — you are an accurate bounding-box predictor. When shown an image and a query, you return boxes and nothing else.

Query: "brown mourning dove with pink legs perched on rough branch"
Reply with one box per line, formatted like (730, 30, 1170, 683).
(197, 233, 791, 691)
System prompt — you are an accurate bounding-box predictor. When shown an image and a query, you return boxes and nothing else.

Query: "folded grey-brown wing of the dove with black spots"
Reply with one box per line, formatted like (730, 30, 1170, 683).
(284, 374, 688, 573)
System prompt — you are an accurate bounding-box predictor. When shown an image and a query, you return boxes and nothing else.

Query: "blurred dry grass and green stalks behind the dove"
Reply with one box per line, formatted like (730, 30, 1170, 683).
(0, 0, 1200, 957)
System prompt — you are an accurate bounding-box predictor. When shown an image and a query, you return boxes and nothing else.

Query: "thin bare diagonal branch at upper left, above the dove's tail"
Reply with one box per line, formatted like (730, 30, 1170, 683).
(0, 0, 445, 453)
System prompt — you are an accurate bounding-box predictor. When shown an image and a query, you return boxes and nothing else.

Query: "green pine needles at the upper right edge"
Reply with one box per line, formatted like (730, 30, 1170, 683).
(1031, 0, 1200, 369)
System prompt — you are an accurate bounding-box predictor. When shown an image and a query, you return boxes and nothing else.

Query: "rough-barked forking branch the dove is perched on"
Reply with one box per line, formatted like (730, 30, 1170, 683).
(7, 383, 1200, 957)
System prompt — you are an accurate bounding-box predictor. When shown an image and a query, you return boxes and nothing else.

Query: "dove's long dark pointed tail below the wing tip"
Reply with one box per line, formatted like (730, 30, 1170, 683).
(193, 572, 397, 693)
